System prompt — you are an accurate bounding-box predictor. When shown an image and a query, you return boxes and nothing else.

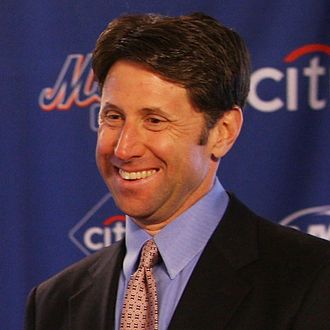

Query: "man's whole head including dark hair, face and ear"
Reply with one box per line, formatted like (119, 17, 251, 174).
(93, 14, 249, 233)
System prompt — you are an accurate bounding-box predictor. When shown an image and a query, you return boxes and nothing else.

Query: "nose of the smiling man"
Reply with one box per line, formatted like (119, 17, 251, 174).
(114, 121, 144, 161)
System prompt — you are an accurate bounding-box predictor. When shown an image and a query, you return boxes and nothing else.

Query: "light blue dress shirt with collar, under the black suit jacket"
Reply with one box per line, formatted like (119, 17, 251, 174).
(115, 178, 229, 330)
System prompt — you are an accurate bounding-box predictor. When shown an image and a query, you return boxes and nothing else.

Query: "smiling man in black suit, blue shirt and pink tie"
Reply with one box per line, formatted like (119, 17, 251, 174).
(26, 14, 330, 330)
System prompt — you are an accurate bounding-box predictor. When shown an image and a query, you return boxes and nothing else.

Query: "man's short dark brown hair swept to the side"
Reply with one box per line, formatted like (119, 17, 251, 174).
(92, 13, 250, 128)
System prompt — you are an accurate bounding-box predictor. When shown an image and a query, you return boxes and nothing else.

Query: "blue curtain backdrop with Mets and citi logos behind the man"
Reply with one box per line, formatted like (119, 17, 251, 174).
(0, 0, 330, 330)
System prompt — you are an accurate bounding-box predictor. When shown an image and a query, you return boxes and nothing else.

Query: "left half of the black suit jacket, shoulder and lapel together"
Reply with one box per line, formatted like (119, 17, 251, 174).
(25, 241, 125, 330)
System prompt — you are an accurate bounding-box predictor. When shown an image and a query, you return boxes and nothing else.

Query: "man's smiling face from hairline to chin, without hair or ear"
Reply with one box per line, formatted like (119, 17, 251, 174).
(96, 60, 217, 224)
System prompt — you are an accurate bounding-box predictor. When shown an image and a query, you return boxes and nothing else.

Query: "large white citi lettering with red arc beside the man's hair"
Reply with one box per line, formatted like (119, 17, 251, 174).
(248, 44, 330, 112)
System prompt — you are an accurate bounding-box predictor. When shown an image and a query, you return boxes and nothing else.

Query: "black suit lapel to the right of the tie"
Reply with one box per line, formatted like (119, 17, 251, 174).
(169, 197, 258, 330)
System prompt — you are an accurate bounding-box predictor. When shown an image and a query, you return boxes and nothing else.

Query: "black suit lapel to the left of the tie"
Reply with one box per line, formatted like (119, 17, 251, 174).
(69, 240, 125, 330)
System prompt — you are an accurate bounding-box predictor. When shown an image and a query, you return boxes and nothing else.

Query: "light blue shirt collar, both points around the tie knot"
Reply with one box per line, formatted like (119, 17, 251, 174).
(123, 178, 229, 279)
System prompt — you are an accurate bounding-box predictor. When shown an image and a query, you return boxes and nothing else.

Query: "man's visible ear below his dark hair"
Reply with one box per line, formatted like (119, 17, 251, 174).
(210, 107, 243, 159)
